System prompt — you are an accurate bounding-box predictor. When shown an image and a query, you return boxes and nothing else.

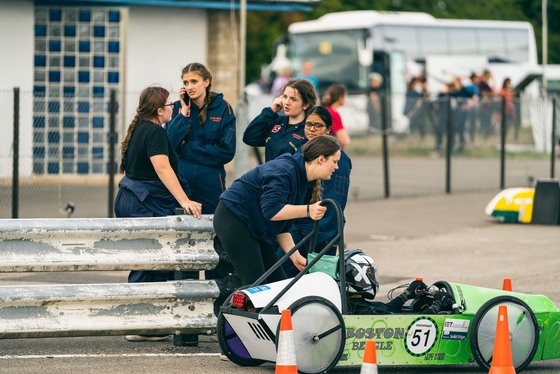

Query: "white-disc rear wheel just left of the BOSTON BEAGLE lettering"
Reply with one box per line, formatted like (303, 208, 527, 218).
(276, 296, 346, 374)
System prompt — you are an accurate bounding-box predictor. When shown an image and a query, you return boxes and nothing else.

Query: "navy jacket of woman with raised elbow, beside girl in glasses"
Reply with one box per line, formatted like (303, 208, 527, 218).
(243, 107, 307, 162)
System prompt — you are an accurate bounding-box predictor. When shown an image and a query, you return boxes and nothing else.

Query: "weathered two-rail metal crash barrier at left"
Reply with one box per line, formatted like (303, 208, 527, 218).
(0, 216, 219, 339)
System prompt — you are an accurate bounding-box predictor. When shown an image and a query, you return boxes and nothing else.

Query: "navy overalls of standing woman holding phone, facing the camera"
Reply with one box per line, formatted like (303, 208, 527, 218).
(165, 92, 236, 214)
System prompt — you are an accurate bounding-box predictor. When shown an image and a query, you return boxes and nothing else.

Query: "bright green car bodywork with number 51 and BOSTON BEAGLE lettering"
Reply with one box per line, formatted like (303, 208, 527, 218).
(338, 283, 560, 366)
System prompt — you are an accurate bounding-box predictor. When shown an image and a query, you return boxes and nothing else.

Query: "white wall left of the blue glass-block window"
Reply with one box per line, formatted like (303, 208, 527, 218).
(0, 0, 34, 178)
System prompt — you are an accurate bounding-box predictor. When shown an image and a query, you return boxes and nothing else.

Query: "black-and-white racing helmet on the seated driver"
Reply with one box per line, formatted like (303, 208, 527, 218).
(344, 249, 379, 300)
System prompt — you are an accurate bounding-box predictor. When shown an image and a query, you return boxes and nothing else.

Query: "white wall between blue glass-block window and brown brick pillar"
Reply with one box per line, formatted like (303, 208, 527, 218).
(123, 6, 208, 134)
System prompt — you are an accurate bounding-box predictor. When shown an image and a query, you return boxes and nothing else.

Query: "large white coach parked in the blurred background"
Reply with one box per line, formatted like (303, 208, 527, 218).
(275, 11, 538, 133)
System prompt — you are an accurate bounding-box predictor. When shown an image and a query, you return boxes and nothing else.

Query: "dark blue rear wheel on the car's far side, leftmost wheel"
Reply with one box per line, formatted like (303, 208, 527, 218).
(217, 292, 264, 366)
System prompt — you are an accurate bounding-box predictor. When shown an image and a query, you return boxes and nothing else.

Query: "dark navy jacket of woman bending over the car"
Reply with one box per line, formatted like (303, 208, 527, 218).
(220, 154, 311, 245)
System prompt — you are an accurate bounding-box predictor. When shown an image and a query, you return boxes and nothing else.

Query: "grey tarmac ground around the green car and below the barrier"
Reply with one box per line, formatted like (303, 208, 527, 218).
(0, 190, 560, 374)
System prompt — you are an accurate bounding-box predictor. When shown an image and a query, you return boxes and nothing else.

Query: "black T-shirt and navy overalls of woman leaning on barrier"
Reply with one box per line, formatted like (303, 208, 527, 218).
(115, 120, 190, 283)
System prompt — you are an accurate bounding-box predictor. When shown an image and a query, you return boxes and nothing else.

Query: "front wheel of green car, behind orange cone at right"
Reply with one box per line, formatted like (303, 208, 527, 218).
(470, 296, 539, 373)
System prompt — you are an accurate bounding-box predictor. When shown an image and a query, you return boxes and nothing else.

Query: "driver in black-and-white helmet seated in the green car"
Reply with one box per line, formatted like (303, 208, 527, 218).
(344, 249, 453, 315)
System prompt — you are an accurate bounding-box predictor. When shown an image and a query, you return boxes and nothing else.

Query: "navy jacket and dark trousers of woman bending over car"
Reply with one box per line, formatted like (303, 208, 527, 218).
(214, 153, 313, 284)
